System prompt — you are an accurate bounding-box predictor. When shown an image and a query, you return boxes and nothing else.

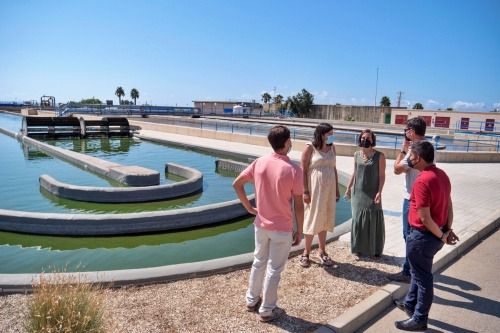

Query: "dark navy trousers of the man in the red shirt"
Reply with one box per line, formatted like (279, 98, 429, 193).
(404, 229, 444, 322)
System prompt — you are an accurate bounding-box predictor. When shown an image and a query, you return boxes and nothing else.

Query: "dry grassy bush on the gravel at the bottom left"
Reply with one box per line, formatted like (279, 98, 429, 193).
(25, 274, 105, 333)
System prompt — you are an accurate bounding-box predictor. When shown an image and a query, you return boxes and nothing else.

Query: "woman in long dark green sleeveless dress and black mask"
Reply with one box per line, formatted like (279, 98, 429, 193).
(345, 129, 385, 257)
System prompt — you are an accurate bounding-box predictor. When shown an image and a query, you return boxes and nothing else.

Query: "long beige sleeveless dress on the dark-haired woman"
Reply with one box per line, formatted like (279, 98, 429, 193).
(303, 143, 337, 235)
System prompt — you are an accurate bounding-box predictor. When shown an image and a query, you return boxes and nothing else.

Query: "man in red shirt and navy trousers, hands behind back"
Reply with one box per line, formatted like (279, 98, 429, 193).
(395, 141, 458, 331)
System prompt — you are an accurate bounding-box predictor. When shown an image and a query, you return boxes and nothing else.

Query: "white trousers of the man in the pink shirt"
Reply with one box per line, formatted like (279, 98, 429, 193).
(246, 227, 292, 316)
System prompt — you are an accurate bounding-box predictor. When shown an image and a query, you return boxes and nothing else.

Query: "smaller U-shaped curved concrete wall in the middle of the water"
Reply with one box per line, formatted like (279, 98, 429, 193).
(39, 163, 203, 203)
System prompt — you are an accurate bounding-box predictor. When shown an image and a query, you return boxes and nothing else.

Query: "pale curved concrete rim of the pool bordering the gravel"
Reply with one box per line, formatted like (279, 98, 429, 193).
(0, 221, 350, 295)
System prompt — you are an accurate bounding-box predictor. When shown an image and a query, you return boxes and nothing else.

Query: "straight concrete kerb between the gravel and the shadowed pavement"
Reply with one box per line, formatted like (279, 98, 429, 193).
(314, 210, 500, 333)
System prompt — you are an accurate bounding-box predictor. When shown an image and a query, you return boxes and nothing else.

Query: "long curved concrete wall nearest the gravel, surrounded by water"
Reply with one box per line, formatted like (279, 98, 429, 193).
(0, 197, 253, 236)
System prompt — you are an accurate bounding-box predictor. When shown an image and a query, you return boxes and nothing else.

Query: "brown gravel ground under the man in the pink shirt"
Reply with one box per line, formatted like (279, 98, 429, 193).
(0, 241, 399, 333)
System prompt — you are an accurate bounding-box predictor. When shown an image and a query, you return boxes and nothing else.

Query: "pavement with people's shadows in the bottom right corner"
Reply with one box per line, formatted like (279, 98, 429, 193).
(359, 229, 500, 333)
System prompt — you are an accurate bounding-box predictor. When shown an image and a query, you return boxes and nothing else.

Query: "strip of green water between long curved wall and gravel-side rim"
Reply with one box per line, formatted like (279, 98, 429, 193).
(0, 218, 253, 273)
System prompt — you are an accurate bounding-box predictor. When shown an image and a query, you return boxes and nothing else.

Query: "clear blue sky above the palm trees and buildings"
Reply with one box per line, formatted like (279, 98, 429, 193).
(0, 0, 500, 111)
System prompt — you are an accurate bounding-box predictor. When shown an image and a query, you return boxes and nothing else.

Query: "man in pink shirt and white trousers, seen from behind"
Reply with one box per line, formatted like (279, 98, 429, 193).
(233, 126, 304, 322)
